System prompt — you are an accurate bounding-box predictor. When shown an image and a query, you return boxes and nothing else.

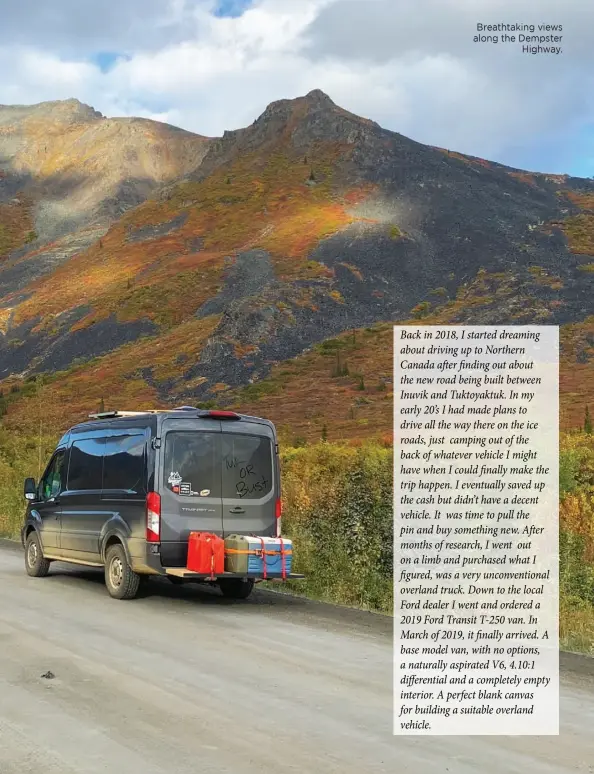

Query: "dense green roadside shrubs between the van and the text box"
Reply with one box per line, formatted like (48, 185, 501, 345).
(282, 442, 393, 613)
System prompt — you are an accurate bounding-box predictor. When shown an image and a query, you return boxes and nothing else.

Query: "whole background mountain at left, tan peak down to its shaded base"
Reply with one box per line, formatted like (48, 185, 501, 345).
(0, 99, 208, 322)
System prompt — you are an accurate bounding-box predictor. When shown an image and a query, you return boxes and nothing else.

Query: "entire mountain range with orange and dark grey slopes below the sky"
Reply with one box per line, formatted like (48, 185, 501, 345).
(0, 90, 594, 436)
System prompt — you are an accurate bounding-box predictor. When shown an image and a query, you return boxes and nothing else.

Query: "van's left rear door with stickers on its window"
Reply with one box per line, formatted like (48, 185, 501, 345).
(156, 417, 223, 567)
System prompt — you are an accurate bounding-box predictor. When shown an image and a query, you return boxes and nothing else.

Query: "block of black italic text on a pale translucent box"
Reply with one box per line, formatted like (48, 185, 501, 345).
(394, 325, 559, 735)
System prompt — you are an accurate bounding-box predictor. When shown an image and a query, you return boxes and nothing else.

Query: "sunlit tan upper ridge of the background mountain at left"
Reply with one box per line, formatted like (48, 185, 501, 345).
(0, 100, 208, 246)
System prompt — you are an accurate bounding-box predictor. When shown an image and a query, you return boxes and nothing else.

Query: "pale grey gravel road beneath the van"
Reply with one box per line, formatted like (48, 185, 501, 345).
(0, 541, 594, 774)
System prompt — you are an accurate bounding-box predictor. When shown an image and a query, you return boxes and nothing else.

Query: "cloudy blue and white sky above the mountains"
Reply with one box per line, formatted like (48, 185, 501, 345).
(0, 0, 594, 177)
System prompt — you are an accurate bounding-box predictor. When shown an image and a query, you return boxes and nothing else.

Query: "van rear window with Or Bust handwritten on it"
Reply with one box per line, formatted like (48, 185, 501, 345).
(222, 433, 272, 500)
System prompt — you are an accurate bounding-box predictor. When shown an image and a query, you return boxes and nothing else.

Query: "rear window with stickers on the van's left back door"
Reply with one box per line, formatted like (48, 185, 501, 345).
(163, 431, 221, 497)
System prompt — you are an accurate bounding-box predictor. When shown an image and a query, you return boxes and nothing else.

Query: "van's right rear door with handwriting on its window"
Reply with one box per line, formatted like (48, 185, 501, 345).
(221, 419, 280, 537)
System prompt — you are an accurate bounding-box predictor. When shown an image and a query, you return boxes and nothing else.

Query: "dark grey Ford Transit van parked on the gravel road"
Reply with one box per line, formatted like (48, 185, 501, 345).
(21, 406, 281, 599)
